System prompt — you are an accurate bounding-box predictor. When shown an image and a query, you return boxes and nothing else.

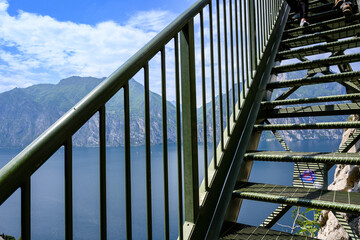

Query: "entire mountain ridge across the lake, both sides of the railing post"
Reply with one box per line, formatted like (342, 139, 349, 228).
(0, 72, 346, 148)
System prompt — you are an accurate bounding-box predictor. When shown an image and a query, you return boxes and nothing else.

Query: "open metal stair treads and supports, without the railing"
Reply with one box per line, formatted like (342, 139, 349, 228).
(221, 1, 360, 239)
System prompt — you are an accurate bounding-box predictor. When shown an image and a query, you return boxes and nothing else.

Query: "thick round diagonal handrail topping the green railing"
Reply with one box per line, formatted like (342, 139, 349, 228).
(0, 0, 209, 204)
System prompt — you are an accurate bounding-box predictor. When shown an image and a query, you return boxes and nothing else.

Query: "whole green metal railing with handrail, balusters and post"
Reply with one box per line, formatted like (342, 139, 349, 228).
(0, 0, 289, 240)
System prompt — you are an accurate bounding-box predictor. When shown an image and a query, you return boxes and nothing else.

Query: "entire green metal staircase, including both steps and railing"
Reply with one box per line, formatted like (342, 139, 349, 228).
(0, 0, 360, 240)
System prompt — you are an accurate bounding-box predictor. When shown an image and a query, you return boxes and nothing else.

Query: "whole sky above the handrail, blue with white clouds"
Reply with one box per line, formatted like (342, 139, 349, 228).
(0, 0, 195, 93)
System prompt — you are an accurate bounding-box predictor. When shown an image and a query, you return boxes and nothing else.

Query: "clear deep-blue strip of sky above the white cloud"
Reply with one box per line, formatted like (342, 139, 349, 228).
(8, 0, 194, 24)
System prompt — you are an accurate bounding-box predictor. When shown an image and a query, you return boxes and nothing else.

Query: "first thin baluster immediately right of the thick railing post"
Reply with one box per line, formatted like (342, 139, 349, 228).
(200, 9, 209, 190)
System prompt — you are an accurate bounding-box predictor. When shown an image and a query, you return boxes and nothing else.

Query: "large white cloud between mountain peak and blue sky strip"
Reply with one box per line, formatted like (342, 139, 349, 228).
(0, 0, 174, 92)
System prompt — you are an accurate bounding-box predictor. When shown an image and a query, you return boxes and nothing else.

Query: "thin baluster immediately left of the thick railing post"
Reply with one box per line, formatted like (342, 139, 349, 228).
(174, 35, 184, 240)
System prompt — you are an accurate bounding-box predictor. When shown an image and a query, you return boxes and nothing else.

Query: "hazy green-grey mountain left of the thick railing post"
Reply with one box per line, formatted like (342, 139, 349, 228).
(0, 77, 176, 148)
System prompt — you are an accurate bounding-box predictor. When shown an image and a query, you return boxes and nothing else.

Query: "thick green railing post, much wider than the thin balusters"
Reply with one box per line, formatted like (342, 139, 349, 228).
(180, 20, 199, 226)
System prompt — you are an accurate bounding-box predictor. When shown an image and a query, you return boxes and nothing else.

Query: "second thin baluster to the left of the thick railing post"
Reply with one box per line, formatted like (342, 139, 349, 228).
(161, 46, 170, 239)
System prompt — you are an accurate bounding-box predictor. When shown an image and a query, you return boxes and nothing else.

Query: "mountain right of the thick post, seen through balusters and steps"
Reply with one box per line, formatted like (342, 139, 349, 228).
(197, 71, 348, 145)
